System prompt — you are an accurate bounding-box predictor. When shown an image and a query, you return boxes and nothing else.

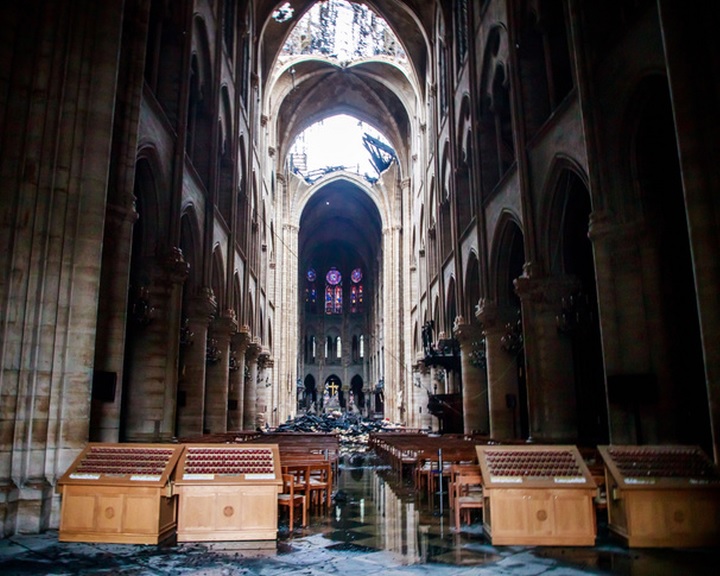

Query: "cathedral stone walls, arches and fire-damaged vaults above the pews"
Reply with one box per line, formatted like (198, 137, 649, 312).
(0, 0, 720, 536)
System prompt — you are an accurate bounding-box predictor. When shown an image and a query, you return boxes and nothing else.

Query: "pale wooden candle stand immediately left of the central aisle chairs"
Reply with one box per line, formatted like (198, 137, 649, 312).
(173, 444, 282, 542)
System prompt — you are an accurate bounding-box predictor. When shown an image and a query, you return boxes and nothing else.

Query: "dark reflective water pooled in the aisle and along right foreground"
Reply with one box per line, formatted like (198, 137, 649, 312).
(281, 457, 720, 576)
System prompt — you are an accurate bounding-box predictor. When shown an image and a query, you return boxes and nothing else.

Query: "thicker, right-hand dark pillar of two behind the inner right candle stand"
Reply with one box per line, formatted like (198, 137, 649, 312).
(515, 264, 577, 442)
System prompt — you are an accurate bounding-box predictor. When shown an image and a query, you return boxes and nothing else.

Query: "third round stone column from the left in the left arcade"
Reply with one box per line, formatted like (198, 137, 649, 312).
(204, 310, 237, 434)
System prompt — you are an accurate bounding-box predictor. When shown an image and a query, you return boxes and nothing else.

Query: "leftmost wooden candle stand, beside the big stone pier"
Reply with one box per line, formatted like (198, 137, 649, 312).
(58, 443, 183, 544)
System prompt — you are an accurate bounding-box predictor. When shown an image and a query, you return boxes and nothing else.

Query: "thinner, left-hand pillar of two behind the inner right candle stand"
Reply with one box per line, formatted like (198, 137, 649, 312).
(476, 300, 520, 439)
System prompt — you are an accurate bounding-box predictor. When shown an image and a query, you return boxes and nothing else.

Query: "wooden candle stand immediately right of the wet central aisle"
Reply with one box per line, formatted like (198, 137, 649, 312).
(476, 446, 597, 546)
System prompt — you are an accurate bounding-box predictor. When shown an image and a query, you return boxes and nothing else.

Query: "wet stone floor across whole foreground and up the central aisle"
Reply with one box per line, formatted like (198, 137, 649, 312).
(0, 456, 720, 576)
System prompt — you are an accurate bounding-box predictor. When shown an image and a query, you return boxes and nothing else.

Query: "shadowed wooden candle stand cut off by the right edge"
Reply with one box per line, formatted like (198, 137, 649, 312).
(598, 446, 720, 547)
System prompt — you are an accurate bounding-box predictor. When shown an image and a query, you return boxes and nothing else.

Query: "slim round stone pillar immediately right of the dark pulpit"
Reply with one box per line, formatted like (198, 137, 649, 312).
(453, 316, 490, 434)
